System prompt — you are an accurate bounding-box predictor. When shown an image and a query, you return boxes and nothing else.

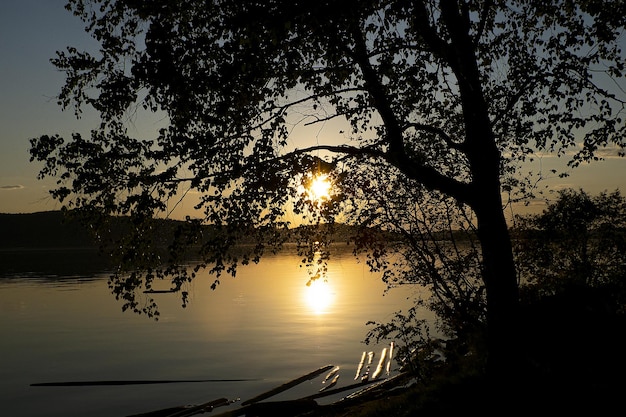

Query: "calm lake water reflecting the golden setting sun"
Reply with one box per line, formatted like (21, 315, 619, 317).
(0, 245, 418, 417)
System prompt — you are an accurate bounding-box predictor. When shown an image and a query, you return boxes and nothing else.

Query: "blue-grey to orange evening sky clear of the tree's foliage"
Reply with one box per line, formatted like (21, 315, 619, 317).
(0, 0, 626, 218)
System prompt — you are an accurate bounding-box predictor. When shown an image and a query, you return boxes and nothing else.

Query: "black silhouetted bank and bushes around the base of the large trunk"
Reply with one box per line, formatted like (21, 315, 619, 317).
(324, 190, 626, 416)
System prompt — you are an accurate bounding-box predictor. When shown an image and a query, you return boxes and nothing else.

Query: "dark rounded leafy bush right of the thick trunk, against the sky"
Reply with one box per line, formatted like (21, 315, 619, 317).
(515, 189, 626, 298)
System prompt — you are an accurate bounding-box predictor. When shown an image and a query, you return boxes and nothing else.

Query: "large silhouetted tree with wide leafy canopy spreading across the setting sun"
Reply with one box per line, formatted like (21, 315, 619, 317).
(31, 0, 626, 384)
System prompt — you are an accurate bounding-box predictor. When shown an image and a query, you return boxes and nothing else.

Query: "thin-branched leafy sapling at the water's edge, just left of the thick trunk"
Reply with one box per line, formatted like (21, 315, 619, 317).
(355, 184, 487, 382)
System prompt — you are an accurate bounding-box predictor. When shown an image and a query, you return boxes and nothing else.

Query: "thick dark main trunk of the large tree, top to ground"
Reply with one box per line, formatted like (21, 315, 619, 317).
(441, 0, 520, 380)
